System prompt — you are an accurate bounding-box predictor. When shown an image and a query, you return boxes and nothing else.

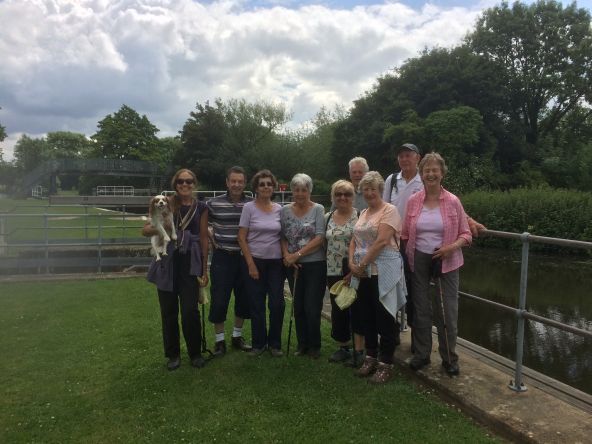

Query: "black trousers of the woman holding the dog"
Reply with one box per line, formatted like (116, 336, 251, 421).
(158, 251, 201, 359)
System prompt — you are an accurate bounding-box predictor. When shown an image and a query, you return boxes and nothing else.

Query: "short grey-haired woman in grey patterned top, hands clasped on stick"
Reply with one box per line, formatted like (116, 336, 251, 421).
(281, 173, 327, 359)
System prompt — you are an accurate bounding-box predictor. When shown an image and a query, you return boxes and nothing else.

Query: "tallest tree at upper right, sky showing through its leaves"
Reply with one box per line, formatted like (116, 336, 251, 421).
(467, 0, 592, 149)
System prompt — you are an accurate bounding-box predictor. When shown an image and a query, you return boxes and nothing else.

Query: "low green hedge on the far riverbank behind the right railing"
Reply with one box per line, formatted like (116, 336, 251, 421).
(462, 187, 592, 252)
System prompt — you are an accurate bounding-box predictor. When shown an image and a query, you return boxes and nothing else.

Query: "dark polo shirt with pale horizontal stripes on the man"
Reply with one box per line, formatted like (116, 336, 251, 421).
(207, 194, 252, 252)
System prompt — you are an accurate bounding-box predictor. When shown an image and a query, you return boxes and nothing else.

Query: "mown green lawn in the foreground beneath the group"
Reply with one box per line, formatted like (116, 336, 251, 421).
(0, 278, 500, 443)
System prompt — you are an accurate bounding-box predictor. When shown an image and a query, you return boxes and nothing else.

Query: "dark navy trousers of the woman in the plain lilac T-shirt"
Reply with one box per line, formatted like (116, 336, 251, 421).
(241, 257, 286, 350)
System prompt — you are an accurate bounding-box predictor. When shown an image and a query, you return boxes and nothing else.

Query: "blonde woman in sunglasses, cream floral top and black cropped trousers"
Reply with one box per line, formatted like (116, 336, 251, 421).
(325, 180, 364, 367)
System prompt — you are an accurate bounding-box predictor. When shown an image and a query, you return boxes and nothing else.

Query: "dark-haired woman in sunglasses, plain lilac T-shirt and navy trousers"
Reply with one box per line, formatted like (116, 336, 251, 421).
(238, 170, 285, 357)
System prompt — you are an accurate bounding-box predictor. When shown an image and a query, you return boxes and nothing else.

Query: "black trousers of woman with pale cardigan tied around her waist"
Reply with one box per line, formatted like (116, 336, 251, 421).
(358, 276, 395, 364)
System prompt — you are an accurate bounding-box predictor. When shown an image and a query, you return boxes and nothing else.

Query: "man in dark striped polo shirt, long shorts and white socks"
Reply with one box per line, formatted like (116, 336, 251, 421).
(207, 166, 251, 356)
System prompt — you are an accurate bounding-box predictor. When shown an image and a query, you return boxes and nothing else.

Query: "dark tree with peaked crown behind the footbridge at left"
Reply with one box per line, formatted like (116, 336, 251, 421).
(91, 105, 160, 161)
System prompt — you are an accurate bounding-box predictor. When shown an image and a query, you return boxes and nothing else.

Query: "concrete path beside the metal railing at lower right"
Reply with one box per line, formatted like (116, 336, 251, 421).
(323, 297, 592, 444)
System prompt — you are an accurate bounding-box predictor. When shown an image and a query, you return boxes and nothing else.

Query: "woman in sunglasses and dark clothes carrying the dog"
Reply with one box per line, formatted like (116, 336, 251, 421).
(142, 169, 208, 370)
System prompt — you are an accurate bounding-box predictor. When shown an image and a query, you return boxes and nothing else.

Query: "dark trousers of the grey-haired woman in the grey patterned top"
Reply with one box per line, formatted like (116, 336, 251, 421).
(287, 261, 327, 350)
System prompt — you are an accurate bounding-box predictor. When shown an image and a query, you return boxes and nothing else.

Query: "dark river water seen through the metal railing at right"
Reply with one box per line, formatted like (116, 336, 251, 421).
(458, 248, 592, 394)
